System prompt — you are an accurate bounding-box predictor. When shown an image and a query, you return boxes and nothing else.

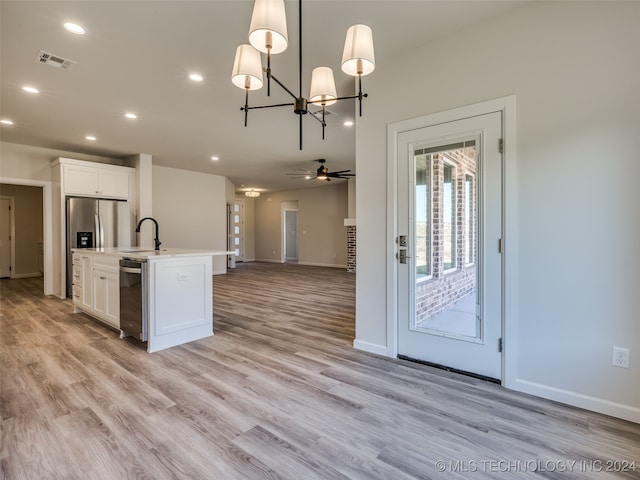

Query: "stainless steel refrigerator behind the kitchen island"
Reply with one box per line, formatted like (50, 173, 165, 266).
(66, 197, 135, 297)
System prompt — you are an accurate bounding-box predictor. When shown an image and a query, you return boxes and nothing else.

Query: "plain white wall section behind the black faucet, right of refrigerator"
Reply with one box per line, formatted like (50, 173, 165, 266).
(152, 166, 227, 274)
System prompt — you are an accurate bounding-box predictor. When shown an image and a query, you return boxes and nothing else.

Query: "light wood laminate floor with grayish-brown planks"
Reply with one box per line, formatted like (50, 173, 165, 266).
(0, 263, 640, 480)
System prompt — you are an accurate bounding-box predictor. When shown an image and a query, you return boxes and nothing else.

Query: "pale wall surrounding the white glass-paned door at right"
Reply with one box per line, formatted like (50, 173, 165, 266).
(356, 2, 640, 422)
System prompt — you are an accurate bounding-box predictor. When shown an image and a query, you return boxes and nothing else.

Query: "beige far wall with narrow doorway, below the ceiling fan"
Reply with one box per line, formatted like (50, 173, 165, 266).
(254, 182, 348, 268)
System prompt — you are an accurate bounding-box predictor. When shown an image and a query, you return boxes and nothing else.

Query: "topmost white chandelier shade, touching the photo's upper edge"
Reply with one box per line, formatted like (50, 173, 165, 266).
(249, 0, 288, 53)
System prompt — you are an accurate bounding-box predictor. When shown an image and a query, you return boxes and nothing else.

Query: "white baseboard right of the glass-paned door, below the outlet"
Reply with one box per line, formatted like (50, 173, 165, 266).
(512, 379, 640, 423)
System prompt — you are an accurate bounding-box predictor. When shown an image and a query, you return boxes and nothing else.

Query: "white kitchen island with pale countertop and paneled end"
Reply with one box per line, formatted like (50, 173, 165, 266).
(72, 247, 233, 352)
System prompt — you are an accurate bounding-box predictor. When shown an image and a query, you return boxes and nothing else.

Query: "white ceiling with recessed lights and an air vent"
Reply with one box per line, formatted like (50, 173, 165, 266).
(0, 0, 524, 191)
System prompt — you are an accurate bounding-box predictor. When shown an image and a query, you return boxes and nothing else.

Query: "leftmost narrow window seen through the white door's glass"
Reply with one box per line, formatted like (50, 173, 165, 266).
(414, 152, 431, 280)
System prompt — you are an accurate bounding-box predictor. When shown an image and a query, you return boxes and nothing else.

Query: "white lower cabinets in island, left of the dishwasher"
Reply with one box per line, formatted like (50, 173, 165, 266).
(73, 252, 120, 329)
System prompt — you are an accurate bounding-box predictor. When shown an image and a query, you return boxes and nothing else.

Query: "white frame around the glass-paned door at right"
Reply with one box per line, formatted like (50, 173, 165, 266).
(386, 95, 518, 388)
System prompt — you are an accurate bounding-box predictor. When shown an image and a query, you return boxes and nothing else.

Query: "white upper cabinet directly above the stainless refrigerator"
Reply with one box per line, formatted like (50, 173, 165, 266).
(58, 159, 133, 199)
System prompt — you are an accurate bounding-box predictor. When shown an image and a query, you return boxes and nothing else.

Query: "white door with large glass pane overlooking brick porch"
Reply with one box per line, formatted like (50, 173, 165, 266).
(397, 112, 502, 380)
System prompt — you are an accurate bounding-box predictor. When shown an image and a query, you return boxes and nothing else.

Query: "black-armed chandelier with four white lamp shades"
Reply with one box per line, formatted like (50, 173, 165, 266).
(231, 0, 375, 150)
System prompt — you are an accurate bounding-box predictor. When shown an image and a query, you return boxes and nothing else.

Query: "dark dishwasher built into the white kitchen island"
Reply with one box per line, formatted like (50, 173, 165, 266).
(120, 258, 149, 342)
